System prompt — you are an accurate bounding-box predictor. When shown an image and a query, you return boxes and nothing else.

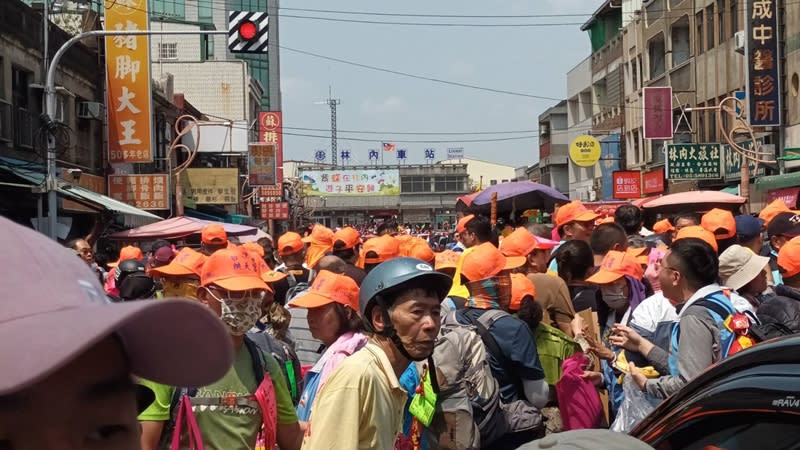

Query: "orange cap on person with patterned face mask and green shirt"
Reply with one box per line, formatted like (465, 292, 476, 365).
(200, 247, 272, 291)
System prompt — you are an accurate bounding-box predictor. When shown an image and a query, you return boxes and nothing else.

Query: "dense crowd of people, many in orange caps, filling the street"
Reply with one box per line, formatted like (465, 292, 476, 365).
(0, 200, 800, 450)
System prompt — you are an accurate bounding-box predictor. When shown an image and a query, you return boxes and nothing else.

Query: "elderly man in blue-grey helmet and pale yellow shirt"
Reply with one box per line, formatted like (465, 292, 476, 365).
(303, 258, 452, 450)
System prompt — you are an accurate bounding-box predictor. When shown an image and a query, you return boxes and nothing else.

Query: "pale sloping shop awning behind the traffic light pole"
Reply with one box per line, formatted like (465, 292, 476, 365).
(0, 158, 163, 227)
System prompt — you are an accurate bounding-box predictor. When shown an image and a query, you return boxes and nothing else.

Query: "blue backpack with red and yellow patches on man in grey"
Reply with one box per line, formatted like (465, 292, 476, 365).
(669, 292, 756, 376)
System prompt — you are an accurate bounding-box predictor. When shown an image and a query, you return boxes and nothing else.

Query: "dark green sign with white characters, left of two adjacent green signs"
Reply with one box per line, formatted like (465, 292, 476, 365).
(667, 144, 725, 180)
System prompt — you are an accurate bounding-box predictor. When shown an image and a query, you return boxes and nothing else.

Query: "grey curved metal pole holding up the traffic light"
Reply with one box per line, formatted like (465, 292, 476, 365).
(44, 29, 228, 240)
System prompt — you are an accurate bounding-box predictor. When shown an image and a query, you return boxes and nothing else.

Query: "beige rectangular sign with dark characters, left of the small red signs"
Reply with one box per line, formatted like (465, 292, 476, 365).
(181, 168, 239, 205)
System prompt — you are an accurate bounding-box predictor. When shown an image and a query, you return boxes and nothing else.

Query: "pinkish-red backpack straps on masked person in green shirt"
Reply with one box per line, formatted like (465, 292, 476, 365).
(158, 333, 277, 450)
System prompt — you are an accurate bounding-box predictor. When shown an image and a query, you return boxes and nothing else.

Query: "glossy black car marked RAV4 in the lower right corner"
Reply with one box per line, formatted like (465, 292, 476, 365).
(630, 335, 800, 450)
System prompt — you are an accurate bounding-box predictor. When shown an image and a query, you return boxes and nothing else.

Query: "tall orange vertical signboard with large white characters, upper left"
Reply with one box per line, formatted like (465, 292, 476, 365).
(104, 0, 153, 163)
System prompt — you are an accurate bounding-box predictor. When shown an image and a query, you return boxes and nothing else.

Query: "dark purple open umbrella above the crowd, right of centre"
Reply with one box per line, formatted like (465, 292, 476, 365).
(472, 181, 569, 212)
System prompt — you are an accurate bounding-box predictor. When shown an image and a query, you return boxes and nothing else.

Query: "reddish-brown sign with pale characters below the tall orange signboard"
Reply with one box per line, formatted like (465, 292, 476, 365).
(108, 173, 169, 209)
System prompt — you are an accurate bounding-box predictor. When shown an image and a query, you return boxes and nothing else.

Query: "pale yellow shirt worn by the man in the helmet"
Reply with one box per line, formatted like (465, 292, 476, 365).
(302, 341, 408, 450)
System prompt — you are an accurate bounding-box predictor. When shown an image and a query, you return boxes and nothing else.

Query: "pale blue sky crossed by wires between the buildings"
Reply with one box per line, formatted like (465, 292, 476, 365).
(280, 0, 599, 166)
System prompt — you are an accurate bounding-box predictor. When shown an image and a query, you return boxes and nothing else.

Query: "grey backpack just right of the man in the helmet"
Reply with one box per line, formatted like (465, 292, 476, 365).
(430, 310, 542, 449)
